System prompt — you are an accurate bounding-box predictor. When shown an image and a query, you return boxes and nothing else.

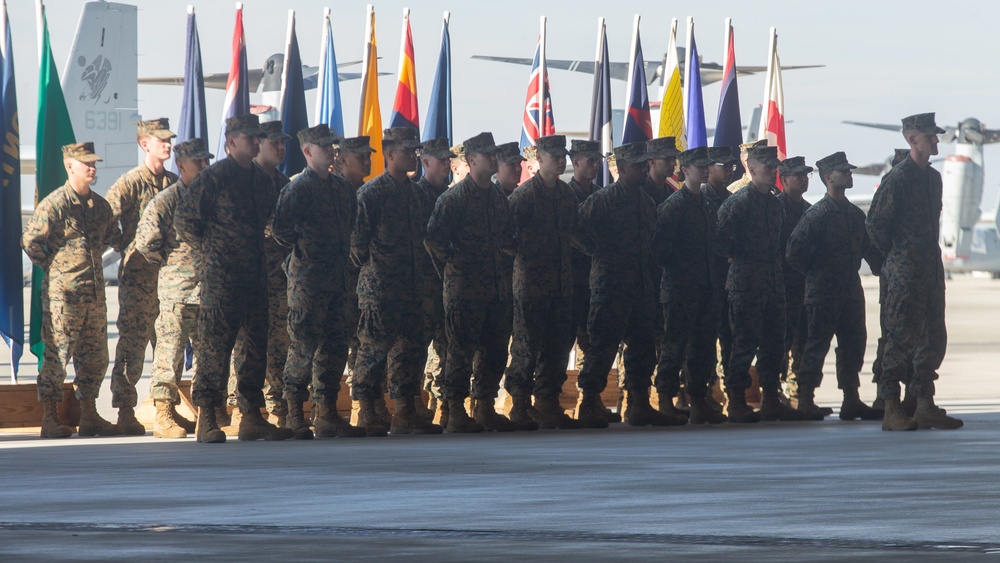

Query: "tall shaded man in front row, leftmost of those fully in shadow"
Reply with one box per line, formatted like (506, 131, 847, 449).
(174, 115, 292, 442)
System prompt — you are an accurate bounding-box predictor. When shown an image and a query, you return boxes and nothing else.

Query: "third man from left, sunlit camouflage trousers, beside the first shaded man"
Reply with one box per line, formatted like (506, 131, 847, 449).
(135, 139, 214, 438)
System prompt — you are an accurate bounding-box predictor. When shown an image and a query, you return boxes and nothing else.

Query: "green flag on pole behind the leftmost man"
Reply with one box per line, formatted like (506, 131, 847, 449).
(29, 4, 76, 369)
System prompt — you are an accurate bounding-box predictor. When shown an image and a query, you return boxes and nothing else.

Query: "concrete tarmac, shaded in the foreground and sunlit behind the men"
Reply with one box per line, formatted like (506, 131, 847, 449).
(0, 277, 1000, 561)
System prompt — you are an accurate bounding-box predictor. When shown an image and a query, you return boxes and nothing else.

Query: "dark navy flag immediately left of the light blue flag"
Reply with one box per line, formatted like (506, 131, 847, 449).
(278, 10, 309, 176)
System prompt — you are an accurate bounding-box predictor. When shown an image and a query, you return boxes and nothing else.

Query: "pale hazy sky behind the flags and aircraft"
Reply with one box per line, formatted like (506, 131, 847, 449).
(8, 0, 1000, 209)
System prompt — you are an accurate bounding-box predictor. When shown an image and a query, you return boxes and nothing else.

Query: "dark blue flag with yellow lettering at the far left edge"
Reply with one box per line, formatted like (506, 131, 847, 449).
(0, 1, 24, 383)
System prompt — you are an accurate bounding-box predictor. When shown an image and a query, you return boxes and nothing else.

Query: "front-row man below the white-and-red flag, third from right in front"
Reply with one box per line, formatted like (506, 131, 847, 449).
(714, 146, 802, 422)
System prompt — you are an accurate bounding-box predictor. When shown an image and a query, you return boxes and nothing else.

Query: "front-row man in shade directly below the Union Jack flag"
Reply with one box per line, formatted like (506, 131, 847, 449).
(504, 135, 584, 429)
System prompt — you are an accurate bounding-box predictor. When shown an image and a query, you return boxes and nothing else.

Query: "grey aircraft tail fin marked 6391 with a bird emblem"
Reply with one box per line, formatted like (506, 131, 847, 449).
(62, 2, 140, 194)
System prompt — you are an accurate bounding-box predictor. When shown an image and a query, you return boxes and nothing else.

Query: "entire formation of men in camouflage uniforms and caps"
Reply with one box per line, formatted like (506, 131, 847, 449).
(22, 114, 962, 443)
